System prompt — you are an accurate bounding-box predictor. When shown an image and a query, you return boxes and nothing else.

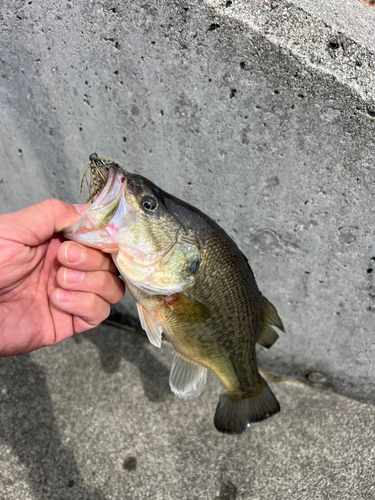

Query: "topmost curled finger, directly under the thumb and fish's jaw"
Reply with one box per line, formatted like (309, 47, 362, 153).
(57, 241, 118, 274)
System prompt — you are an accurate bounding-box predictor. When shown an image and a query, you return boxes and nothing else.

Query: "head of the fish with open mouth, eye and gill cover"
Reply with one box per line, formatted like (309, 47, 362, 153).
(64, 156, 201, 296)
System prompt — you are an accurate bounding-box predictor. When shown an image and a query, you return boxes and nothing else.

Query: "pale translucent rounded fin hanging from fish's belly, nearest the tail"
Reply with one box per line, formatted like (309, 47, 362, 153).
(169, 353, 207, 399)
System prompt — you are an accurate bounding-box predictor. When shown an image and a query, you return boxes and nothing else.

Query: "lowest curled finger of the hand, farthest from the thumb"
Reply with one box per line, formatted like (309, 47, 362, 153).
(50, 288, 111, 333)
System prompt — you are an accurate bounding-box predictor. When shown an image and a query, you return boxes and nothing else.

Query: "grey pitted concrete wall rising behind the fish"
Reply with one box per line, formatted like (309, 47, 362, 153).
(0, 0, 375, 402)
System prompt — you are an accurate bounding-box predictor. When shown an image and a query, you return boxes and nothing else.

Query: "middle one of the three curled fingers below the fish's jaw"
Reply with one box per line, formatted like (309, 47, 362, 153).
(56, 267, 125, 304)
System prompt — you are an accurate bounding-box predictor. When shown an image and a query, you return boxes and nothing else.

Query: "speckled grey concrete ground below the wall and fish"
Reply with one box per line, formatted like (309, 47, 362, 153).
(0, 325, 375, 500)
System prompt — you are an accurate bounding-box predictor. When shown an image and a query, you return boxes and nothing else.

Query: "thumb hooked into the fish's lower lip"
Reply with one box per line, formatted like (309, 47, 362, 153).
(0, 198, 89, 246)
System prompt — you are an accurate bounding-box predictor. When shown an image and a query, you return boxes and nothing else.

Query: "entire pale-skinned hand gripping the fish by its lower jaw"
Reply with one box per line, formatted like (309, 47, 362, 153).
(0, 199, 125, 356)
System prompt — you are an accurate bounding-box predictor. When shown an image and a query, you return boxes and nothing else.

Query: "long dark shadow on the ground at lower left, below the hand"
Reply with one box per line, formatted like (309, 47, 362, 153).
(0, 355, 106, 500)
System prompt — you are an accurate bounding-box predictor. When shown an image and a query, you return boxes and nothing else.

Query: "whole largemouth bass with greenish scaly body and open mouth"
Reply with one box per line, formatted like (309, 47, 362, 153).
(64, 153, 284, 434)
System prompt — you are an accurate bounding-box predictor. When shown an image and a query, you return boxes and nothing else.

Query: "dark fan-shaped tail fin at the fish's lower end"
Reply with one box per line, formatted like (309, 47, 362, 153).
(214, 378, 280, 434)
